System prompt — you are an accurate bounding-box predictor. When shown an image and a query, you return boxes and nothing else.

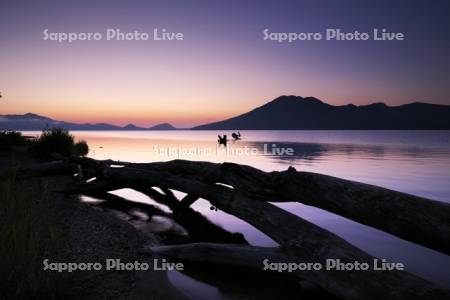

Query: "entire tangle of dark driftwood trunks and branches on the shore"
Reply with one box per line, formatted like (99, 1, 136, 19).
(4, 158, 450, 299)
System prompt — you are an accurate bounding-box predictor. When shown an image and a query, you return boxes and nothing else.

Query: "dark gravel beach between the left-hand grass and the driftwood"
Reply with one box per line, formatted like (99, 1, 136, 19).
(0, 152, 186, 300)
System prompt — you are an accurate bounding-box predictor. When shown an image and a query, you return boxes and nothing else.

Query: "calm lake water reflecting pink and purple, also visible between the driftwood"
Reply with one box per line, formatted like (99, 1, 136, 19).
(25, 130, 450, 299)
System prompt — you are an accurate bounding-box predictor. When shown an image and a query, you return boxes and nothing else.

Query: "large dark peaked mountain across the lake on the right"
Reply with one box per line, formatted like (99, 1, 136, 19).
(192, 96, 450, 130)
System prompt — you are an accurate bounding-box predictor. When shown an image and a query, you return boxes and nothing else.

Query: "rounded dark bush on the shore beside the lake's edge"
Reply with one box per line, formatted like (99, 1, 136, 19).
(32, 128, 74, 159)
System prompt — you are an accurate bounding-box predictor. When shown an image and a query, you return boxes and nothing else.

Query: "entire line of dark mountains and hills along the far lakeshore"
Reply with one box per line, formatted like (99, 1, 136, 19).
(0, 96, 450, 130)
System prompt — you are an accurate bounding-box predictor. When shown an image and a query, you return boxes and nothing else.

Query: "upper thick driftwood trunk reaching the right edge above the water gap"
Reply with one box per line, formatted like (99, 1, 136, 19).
(93, 160, 450, 255)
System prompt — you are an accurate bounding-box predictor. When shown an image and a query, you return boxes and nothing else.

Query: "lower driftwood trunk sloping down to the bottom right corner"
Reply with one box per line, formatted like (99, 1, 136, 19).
(95, 167, 448, 299)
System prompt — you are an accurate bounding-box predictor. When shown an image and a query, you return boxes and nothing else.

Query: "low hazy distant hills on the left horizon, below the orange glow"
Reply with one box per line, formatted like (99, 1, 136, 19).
(0, 113, 176, 130)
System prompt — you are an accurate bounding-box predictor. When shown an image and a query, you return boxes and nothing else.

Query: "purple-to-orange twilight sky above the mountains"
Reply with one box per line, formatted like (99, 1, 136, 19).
(0, 0, 450, 127)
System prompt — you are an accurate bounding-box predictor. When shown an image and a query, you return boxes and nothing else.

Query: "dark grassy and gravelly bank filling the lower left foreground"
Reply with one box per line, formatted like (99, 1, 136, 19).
(0, 151, 188, 299)
